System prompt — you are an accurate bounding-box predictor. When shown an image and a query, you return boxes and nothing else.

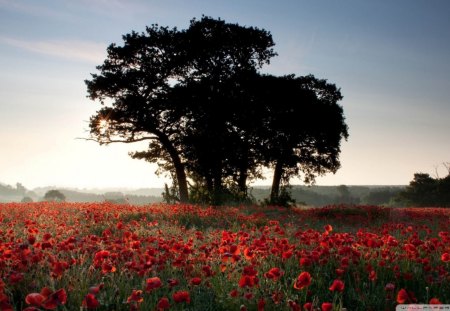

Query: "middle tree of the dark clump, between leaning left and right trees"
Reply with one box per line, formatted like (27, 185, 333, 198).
(167, 72, 267, 201)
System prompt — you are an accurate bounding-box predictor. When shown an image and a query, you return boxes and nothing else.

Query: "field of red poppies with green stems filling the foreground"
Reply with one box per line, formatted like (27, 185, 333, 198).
(0, 202, 450, 311)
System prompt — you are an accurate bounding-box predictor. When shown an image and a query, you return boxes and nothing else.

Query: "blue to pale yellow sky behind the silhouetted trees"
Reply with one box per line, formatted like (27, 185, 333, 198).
(0, 0, 450, 189)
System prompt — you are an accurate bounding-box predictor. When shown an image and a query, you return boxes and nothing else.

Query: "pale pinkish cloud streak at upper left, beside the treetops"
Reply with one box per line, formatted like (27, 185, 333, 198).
(0, 36, 106, 64)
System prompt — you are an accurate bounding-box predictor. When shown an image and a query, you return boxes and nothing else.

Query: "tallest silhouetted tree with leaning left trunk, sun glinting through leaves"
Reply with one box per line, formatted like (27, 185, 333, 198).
(86, 16, 275, 201)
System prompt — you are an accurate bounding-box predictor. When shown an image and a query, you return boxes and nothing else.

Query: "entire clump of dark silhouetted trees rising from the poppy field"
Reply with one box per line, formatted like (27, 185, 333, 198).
(85, 16, 348, 203)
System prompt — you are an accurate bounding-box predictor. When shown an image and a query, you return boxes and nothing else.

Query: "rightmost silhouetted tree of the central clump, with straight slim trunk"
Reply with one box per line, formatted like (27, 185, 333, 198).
(251, 75, 348, 203)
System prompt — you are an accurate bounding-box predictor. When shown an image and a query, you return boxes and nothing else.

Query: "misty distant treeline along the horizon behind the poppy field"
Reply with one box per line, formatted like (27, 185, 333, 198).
(0, 177, 450, 207)
